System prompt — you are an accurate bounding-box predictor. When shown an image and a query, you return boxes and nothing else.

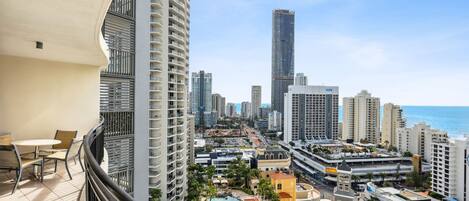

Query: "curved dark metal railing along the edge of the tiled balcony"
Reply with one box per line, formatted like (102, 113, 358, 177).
(83, 118, 133, 201)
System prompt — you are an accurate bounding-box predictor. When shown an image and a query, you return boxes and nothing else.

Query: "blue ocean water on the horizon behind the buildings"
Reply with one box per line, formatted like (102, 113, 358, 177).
(236, 104, 469, 137)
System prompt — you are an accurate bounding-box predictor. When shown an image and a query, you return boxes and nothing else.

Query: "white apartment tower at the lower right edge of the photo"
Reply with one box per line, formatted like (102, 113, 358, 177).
(431, 138, 469, 200)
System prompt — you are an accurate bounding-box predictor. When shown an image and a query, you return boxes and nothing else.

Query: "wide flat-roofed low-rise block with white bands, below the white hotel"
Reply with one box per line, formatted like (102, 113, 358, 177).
(279, 142, 431, 184)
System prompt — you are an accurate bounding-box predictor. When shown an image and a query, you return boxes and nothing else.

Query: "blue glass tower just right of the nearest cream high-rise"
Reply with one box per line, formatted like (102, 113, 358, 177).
(192, 71, 216, 127)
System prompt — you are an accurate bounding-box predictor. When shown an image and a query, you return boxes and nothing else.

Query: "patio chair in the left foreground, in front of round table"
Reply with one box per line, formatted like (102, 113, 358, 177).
(0, 144, 44, 194)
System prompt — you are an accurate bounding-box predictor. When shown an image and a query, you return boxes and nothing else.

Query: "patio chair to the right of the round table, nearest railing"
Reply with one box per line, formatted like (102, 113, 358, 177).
(44, 139, 83, 180)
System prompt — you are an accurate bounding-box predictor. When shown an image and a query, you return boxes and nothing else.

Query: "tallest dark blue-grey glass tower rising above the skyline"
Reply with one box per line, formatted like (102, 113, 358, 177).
(271, 9, 295, 114)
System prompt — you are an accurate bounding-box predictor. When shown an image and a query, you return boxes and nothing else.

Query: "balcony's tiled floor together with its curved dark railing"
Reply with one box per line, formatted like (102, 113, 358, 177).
(0, 121, 132, 201)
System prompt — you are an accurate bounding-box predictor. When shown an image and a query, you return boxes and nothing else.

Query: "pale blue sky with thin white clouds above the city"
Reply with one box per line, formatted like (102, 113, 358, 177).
(190, 0, 469, 106)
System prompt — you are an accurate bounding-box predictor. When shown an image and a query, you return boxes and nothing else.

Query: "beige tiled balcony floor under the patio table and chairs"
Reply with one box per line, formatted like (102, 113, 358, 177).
(0, 160, 85, 201)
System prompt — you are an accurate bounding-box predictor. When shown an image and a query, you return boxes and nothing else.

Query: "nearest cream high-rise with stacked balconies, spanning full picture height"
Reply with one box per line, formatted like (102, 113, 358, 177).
(132, 0, 190, 200)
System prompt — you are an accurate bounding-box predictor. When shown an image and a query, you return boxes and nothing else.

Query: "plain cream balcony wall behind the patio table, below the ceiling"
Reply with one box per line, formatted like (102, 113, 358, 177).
(0, 55, 100, 139)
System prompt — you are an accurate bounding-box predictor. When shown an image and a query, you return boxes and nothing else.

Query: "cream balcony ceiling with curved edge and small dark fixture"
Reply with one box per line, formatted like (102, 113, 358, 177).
(0, 0, 111, 66)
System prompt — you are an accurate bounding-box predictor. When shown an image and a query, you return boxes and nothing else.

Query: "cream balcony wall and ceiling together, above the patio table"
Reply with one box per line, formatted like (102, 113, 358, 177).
(0, 0, 111, 143)
